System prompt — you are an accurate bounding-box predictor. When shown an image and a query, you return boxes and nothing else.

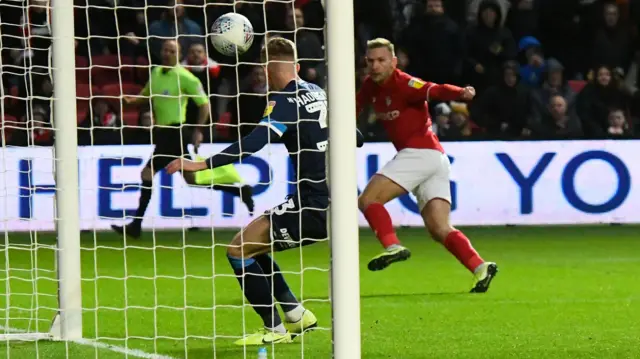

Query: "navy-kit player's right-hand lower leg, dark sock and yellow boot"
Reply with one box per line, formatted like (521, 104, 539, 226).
(255, 254, 318, 337)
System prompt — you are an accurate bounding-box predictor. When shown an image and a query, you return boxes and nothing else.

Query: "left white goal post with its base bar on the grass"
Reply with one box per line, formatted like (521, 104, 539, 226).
(0, 0, 82, 341)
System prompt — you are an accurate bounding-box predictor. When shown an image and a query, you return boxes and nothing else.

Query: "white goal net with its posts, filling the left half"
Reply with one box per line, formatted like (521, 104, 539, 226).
(0, 0, 360, 359)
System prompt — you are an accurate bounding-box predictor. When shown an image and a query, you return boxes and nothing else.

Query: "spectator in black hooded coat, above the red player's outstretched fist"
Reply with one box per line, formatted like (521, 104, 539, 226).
(466, 0, 516, 91)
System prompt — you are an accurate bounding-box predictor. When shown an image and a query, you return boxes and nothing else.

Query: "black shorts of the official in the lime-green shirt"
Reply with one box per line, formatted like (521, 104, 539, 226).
(147, 125, 191, 173)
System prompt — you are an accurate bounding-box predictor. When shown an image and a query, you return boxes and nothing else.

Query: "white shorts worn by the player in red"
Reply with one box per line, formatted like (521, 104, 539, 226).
(378, 148, 451, 211)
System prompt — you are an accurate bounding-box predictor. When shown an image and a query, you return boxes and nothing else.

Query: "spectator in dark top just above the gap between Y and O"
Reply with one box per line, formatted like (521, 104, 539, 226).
(529, 93, 582, 139)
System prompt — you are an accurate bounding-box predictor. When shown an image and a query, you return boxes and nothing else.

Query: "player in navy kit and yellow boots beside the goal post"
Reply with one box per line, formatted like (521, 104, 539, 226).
(167, 38, 362, 345)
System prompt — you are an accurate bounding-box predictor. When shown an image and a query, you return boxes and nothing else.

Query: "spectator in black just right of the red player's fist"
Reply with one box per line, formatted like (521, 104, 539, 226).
(471, 61, 531, 137)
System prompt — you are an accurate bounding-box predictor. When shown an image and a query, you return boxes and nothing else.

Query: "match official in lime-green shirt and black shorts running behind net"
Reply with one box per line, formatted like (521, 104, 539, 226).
(111, 40, 254, 238)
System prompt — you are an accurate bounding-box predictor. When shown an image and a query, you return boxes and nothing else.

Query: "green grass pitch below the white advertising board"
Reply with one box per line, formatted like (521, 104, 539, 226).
(0, 226, 640, 359)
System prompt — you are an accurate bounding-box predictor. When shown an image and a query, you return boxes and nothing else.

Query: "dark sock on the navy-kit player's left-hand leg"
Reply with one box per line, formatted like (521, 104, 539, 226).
(227, 255, 282, 328)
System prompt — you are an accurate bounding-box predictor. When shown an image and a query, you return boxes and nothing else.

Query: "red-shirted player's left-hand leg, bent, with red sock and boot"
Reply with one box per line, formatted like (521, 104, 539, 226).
(358, 174, 411, 271)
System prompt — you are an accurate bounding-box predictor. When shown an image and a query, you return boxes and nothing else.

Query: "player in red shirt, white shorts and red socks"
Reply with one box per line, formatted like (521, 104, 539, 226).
(357, 39, 498, 293)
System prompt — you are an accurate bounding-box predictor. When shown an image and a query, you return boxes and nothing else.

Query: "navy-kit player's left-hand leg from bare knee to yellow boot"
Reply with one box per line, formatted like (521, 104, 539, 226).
(227, 216, 292, 345)
